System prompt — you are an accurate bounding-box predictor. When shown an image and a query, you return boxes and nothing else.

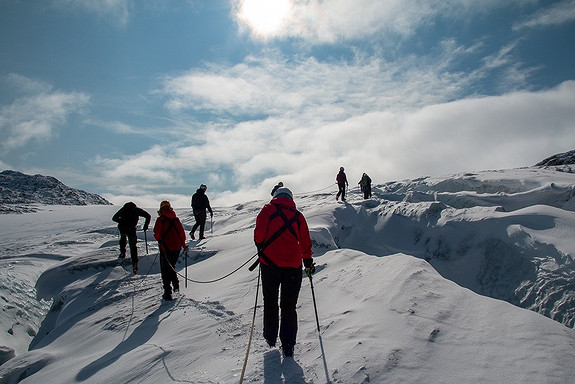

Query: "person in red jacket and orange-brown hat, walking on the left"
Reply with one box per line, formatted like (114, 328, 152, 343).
(154, 201, 188, 300)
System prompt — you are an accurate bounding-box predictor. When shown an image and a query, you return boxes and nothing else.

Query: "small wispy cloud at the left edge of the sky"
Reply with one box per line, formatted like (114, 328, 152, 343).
(0, 76, 90, 152)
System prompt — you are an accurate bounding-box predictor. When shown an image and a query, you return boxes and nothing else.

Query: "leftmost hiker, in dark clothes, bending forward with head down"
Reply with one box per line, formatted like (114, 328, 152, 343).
(112, 201, 152, 274)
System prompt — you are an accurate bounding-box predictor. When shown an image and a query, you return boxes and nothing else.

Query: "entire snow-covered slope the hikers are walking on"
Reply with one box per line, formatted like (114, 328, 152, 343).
(0, 167, 575, 384)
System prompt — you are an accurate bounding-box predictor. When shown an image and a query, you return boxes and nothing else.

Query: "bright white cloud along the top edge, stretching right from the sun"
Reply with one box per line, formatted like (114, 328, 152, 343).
(233, 0, 536, 44)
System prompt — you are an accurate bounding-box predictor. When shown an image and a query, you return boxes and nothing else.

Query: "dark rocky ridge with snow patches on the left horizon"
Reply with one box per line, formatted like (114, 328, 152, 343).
(0, 170, 112, 213)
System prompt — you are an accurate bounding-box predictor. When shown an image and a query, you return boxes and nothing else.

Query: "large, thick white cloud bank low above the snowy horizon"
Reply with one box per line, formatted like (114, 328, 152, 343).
(102, 81, 575, 205)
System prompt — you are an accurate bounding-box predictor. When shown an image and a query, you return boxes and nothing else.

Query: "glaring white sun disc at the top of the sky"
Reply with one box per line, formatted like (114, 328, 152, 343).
(239, 0, 291, 37)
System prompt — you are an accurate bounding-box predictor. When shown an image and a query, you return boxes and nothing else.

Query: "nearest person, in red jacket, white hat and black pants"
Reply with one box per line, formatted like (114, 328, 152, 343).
(254, 187, 315, 356)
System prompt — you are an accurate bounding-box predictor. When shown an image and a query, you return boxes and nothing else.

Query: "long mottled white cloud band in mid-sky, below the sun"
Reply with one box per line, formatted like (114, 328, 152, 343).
(161, 48, 489, 120)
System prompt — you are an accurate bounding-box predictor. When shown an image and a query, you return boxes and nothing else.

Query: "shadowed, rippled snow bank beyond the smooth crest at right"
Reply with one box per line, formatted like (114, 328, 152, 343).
(323, 168, 575, 327)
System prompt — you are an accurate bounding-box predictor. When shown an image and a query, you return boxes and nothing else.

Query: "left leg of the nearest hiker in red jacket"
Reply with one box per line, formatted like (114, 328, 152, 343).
(260, 264, 280, 347)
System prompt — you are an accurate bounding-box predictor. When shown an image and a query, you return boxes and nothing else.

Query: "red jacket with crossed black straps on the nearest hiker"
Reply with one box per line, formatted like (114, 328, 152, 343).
(254, 196, 313, 268)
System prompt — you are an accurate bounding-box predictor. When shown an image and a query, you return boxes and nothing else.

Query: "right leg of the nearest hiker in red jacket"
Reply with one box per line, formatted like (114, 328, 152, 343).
(280, 268, 302, 356)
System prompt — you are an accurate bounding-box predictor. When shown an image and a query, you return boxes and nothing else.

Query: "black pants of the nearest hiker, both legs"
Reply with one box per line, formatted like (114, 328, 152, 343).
(261, 264, 302, 346)
